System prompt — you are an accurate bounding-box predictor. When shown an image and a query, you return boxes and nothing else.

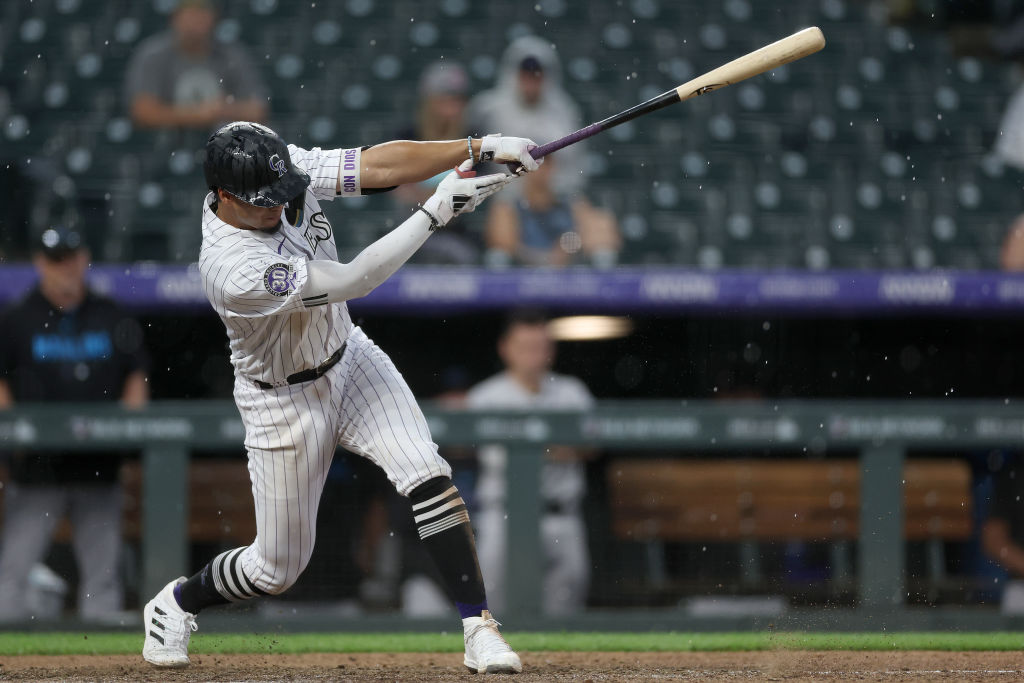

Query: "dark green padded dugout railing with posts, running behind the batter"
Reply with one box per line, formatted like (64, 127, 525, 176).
(0, 400, 1024, 628)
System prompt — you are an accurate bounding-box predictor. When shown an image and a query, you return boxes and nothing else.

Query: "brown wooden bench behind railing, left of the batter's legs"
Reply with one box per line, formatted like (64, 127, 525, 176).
(0, 458, 256, 546)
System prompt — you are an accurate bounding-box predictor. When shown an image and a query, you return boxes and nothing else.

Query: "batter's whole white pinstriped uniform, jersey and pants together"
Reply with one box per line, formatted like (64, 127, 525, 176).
(167, 133, 452, 601)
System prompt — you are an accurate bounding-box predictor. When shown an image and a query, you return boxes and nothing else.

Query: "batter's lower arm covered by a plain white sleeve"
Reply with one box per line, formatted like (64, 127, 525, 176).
(302, 211, 430, 303)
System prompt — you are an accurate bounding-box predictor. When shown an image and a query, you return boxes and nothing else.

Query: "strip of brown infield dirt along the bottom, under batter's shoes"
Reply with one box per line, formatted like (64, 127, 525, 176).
(0, 650, 1024, 683)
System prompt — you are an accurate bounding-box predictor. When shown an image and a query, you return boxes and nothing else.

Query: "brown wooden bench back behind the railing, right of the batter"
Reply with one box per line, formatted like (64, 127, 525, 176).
(607, 459, 971, 542)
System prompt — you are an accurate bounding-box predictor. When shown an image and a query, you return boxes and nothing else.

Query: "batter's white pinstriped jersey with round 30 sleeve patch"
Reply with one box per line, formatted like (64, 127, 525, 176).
(199, 144, 360, 384)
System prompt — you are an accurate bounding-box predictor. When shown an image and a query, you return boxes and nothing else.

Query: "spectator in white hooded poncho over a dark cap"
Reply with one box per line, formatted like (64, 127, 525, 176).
(466, 36, 587, 201)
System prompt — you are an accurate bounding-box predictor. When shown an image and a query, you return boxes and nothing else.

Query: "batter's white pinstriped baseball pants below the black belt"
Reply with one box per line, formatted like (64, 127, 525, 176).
(234, 328, 452, 594)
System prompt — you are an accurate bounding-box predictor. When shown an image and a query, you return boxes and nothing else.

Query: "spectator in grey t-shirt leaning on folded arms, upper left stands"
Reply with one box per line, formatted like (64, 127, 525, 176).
(125, 0, 267, 133)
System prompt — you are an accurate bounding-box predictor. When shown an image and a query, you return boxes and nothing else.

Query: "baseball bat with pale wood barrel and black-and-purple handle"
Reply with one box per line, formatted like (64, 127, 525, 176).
(529, 27, 825, 159)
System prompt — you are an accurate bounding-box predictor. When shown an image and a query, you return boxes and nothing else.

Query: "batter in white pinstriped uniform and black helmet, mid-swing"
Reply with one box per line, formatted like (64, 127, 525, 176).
(142, 122, 538, 673)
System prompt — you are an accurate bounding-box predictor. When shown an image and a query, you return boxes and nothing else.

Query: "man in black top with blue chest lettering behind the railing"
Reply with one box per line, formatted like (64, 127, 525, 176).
(0, 227, 148, 621)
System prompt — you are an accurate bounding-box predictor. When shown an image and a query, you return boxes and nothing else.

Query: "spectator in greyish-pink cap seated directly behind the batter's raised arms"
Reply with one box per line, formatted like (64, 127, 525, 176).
(391, 59, 480, 265)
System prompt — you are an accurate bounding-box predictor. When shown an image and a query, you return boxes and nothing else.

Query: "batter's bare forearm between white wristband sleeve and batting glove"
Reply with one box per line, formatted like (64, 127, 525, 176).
(360, 139, 480, 187)
